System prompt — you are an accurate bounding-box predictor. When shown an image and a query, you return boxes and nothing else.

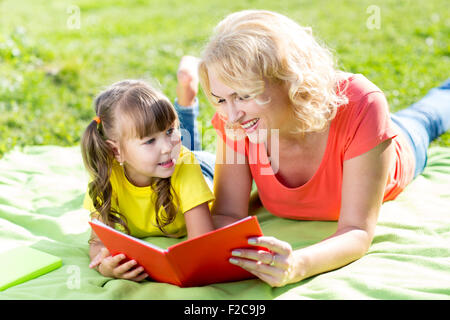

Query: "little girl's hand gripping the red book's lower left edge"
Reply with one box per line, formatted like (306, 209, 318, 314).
(89, 248, 148, 282)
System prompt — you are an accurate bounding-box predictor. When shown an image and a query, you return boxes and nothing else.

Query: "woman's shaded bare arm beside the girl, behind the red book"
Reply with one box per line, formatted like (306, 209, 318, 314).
(211, 137, 252, 228)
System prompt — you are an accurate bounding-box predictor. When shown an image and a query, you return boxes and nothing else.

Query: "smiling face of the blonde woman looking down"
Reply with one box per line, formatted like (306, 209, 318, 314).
(208, 70, 290, 143)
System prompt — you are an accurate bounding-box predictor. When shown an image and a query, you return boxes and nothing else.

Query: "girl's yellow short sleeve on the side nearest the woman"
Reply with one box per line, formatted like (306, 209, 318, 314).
(171, 151, 214, 214)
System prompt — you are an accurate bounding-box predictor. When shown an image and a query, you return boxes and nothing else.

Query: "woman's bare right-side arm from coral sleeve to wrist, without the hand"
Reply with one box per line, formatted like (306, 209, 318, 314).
(296, 139, 393, 278)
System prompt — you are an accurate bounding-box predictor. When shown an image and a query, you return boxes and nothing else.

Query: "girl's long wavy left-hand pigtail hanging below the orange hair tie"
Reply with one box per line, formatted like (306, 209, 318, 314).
(81, 120, 130, 234)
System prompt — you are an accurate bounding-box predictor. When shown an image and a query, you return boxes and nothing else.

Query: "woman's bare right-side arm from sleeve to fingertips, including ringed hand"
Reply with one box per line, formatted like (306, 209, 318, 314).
(231, 139, 394, 287)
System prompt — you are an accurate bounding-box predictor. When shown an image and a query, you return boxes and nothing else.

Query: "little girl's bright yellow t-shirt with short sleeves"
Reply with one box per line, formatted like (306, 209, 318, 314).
(83, 146, 214, 238)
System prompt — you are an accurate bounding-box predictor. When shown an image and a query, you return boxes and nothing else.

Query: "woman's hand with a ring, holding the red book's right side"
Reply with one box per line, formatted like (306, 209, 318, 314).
(229, 236, 299, 287)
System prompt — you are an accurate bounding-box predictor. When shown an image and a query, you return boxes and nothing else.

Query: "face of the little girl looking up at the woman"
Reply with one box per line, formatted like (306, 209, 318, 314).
(116, 125, 181, 187)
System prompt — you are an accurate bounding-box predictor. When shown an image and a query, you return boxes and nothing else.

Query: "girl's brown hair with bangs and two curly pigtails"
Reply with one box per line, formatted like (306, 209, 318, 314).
(81, 80, 179, 235)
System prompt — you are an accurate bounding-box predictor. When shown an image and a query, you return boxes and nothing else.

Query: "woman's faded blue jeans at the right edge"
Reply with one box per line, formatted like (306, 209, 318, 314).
(391, 78, 450, 178)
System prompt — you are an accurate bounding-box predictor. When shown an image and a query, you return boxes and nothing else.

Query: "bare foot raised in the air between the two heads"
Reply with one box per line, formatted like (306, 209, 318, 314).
(177, 56, 200, 107)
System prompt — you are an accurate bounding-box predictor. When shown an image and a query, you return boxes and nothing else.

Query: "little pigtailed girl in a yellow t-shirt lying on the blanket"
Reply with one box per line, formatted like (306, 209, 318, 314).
(81, 59, 214, 281)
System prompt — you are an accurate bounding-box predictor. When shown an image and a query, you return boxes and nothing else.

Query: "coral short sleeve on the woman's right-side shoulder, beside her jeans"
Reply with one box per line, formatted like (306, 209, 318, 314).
(344, 91, 396, 160)
